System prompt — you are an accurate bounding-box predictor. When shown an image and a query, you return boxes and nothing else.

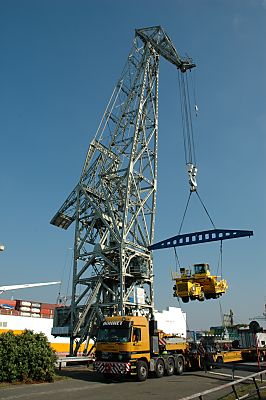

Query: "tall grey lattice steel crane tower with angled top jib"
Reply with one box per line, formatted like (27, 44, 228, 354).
(51, 26, 195, 354)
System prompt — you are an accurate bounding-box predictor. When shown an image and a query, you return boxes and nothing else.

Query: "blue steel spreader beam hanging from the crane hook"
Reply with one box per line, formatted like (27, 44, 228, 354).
(148, 229, 253, 250)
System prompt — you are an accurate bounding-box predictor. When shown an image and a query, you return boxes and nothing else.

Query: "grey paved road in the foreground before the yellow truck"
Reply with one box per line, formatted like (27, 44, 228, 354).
(0, 367, 264, 400)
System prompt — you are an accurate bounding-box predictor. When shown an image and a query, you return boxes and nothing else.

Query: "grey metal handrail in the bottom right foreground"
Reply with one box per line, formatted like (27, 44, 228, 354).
(179, 371, 266, 400)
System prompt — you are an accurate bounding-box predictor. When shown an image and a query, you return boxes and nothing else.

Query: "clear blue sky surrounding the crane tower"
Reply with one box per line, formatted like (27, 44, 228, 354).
(0, 0, 266, 329)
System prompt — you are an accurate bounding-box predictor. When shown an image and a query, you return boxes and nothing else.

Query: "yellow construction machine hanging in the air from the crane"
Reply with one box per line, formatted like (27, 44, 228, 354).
(172, 264, 228, 303)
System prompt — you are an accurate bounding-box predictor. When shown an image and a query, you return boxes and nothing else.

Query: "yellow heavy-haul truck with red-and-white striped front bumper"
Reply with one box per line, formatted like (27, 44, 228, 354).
(94, 316, 189, 381)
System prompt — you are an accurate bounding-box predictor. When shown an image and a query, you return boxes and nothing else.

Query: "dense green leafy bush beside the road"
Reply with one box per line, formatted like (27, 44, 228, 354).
(0, 330, 56, 382)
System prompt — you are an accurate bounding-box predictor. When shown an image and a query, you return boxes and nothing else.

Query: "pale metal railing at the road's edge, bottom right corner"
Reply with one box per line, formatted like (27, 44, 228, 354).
(179, 371, 266, 400)
